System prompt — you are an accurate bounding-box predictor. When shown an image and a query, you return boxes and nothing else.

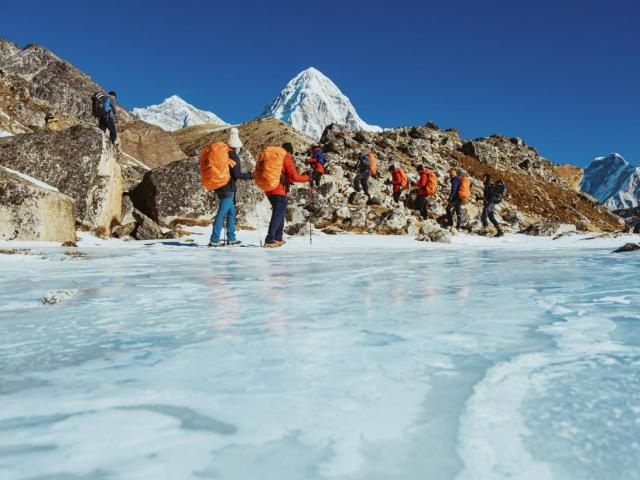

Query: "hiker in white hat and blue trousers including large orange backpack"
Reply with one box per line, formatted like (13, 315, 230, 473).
(200, 128, 253, 247)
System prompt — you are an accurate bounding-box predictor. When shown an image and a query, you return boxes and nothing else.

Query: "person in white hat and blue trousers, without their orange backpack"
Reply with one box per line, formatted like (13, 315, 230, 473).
(209, 127, 253, 247)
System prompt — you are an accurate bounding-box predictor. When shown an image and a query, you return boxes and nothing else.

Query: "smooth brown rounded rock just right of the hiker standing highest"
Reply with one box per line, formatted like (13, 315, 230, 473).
(118, 120, 187, 168)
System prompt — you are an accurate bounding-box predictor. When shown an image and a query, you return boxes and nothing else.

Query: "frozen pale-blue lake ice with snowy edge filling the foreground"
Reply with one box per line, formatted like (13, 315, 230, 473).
(0, 229, 640, 480)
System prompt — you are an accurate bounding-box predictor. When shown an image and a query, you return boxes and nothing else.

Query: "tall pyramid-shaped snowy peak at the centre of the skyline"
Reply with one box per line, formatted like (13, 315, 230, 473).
(260, 67, 382, 140)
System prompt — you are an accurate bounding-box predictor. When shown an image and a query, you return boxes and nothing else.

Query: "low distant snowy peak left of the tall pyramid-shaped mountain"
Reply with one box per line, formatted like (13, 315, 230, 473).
(131, 95, 227, 132)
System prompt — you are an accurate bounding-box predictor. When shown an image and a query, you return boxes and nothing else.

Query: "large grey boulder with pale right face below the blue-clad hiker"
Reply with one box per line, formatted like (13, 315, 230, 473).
(0, 126, 122, 235)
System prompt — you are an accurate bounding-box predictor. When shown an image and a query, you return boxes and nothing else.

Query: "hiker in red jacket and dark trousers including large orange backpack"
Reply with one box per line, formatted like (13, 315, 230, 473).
(255, 143, 311, 248)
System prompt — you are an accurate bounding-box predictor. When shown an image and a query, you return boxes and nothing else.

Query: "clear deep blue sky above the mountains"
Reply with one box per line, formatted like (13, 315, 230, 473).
(0, 0, 640, 166)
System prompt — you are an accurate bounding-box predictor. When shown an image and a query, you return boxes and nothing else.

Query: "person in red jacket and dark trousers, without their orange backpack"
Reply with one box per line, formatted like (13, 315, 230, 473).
(264, 143, 310, 248)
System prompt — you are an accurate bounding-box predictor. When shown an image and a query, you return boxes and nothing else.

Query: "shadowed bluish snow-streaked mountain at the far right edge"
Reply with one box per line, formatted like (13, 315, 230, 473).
(580, 153, 640, 210)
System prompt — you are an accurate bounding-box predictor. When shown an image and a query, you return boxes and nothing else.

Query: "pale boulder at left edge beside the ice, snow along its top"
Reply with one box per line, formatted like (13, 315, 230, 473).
(0, 167, 76, 243)
